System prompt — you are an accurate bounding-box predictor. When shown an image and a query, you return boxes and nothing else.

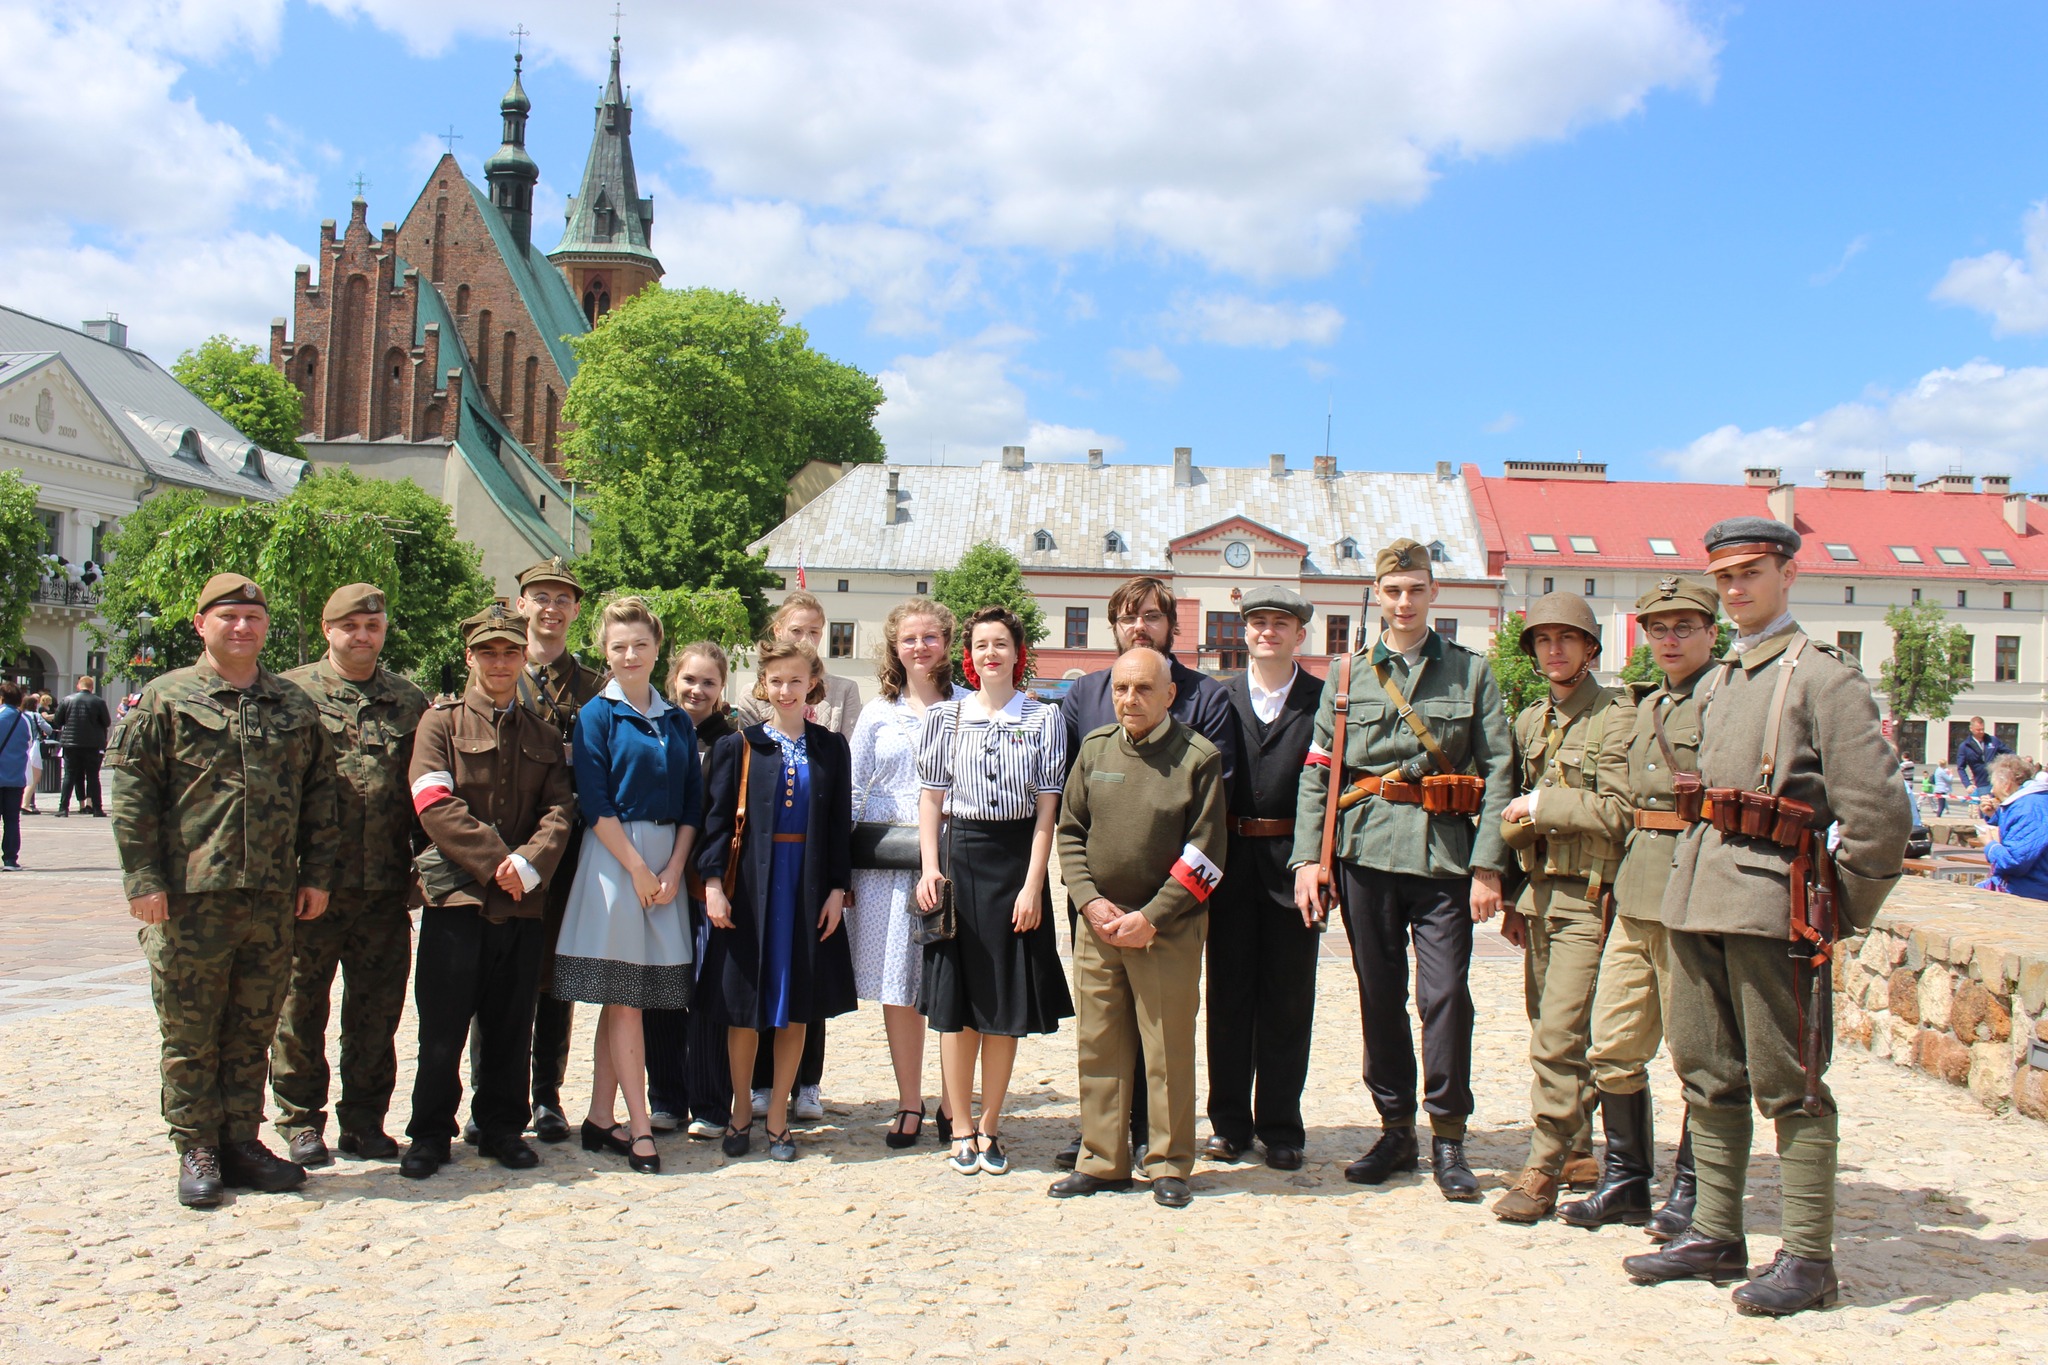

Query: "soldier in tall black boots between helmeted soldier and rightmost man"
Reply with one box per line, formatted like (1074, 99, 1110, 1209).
(1556, 575, 1720, 1242)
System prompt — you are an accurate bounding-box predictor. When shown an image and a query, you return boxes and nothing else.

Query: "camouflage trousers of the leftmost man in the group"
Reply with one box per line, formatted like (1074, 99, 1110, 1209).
(137, 890, 295, 1152)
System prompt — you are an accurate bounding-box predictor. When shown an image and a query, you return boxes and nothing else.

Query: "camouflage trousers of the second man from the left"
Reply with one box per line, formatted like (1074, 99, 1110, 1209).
(270, 888, 412, 1140)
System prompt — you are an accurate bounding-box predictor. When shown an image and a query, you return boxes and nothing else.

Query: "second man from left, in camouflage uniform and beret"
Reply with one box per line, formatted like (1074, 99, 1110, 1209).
(270, 583, 426, 1166)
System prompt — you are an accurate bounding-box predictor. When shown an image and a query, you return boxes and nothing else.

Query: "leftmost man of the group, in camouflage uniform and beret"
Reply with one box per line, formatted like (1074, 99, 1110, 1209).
(109, 573, 338, 1209)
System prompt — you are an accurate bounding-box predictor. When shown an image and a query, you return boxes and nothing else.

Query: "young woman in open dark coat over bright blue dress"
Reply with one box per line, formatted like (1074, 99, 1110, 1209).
(696, 641, 856, 1160)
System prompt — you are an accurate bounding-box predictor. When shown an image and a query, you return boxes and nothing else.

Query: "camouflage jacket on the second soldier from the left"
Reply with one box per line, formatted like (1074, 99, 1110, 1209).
(285, 657, 426, 890)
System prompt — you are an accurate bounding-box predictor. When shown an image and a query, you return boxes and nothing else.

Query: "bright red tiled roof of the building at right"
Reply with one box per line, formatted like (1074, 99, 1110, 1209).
(1464, 465, 2048, 579)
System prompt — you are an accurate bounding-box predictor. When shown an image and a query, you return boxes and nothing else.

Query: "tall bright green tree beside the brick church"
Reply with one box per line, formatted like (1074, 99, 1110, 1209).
(563, 289, 883, 622)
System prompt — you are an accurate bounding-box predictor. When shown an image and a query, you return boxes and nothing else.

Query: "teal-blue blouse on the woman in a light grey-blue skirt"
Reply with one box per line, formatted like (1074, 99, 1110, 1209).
(573, 684, 705, 829)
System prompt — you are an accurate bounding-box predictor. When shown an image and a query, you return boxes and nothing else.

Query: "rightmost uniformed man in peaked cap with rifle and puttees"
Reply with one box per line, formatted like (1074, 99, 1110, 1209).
(1622, 516, 1911, 1316)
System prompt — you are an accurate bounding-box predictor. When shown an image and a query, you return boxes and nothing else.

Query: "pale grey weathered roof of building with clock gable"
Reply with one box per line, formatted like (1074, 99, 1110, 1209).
(750, 460, 1487, 579)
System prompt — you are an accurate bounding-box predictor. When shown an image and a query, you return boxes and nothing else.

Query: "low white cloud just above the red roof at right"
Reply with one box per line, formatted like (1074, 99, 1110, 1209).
(1663, 360, 2048, 481)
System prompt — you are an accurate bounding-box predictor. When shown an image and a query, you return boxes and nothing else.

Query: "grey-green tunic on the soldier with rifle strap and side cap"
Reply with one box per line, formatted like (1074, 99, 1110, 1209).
(1288, 630, 1513, 876)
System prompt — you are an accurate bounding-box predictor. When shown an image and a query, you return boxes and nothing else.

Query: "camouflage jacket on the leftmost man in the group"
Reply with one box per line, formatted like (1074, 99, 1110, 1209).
(106, 657, 340, 900)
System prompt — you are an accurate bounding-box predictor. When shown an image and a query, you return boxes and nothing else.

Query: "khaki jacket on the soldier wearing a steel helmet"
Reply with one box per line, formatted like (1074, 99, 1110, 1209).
(1501, 673, 1636, 915)
